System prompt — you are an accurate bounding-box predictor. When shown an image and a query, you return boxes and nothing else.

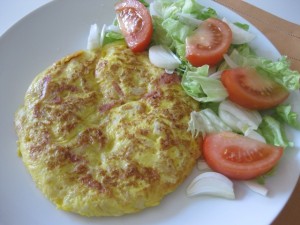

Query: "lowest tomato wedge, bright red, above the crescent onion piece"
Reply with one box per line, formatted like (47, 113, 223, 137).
(202, 131, 283, 180)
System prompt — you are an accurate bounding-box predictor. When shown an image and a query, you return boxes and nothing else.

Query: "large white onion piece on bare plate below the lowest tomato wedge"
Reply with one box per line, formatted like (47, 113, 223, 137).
(186, 172, 235, 199)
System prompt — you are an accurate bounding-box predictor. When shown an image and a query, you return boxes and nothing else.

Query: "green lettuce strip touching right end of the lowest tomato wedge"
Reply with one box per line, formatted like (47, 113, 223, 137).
(258, 115, 294, 148)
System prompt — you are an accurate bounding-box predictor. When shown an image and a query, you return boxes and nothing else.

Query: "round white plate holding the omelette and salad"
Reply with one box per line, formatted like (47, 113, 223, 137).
(0, 0, 300, 225)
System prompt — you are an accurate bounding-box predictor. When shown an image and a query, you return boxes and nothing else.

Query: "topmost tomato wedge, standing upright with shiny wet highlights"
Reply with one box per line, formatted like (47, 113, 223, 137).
(115, 0, 153, 52)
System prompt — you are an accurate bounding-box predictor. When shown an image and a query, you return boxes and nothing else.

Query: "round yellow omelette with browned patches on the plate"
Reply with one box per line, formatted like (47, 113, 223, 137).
(15, 42, 200, 216)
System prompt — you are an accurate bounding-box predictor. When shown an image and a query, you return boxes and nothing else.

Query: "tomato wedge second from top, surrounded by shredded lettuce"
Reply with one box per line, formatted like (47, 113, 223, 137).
(186, 18, 232, 66)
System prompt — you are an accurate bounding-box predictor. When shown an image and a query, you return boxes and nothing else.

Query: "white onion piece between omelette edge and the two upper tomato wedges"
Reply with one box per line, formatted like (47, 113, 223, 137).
(149, 45, 181, 70)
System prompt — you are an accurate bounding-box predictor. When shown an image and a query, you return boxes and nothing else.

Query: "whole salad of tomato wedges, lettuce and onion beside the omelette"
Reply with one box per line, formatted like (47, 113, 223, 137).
(88, 0, 300, 199)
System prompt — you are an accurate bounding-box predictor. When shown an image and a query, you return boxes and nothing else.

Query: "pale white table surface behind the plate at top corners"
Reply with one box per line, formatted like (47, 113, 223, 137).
(0, 0, 300, 36)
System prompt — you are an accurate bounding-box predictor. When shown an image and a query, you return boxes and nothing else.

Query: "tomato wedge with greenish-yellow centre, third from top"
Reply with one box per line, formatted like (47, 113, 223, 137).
(221, 68, 289, 110)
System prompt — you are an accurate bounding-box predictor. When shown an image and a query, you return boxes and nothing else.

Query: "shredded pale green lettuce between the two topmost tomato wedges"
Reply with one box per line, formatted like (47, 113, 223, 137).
(150, 0, 217, 61)
